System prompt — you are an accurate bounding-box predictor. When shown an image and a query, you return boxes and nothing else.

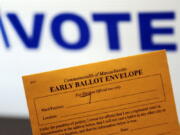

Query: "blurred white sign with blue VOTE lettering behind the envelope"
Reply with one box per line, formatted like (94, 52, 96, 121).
(0, 0, 180, 121)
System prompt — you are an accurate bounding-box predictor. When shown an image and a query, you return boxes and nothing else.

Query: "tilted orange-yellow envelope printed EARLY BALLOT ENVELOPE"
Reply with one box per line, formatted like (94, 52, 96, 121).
(23, 50, 180, 135)
